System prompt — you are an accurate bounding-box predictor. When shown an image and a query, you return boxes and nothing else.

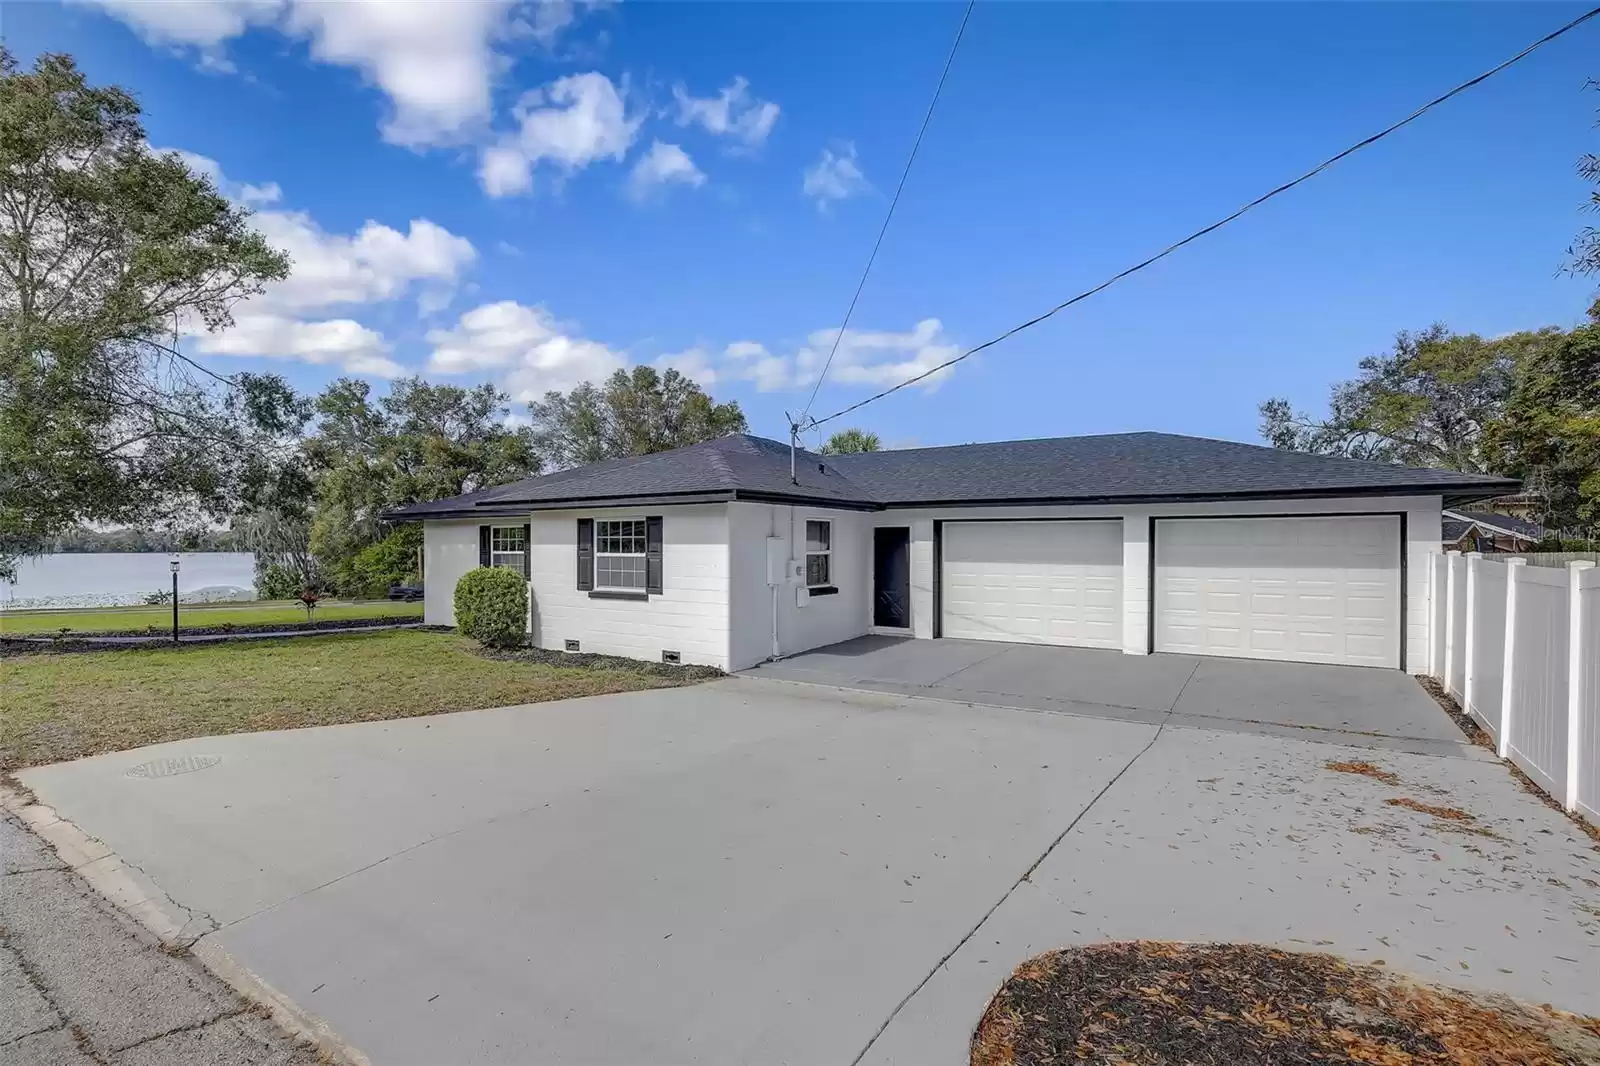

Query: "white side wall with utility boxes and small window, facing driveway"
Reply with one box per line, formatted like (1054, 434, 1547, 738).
(728, 503, 876, 669)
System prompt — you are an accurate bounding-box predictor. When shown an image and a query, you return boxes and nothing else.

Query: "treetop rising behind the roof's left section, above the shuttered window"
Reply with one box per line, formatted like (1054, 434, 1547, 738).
(528, 367, 747, 467)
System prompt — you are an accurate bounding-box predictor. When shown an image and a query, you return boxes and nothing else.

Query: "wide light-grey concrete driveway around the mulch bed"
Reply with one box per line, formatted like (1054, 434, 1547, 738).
(19, 679, 1600, 1066)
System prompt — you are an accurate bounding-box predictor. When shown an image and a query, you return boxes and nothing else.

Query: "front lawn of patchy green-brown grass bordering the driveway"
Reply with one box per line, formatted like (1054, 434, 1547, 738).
(0, 629, 700, 771)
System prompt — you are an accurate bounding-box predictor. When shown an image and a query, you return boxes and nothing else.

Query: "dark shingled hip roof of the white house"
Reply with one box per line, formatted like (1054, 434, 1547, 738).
(386, 432, 1520, 520)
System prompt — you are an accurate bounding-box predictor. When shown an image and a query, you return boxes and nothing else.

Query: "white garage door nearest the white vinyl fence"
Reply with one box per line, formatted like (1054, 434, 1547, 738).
(1155, 515, 1402, 667)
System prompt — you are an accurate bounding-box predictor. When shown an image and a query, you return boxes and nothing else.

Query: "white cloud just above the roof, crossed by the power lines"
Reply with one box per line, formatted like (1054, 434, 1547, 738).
(722, 319, 962, 392)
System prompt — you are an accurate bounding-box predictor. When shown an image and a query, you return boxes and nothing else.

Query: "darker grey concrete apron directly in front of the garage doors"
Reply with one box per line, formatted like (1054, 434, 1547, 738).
(749, 635, 1462, 754)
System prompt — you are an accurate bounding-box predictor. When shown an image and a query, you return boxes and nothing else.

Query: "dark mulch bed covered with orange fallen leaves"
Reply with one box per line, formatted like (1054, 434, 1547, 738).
(971, 941, 1600, 1066)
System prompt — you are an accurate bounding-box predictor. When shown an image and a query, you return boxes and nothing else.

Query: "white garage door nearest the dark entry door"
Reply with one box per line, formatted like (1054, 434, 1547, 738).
(941, 520, 1122, 648)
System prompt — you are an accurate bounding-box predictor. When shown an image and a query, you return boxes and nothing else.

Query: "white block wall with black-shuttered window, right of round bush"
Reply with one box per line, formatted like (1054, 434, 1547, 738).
(531, 504, 730, 669)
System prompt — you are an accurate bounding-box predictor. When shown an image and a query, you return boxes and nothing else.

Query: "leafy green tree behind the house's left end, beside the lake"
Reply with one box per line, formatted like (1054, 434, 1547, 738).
(306, 378, 539, 592)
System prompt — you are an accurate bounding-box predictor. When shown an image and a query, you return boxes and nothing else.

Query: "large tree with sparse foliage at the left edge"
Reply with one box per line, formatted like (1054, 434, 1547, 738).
(0, 48, 296, 573)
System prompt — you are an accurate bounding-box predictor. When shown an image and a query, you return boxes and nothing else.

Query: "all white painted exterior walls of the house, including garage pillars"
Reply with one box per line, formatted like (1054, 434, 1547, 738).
(424, 496, 1440, 674)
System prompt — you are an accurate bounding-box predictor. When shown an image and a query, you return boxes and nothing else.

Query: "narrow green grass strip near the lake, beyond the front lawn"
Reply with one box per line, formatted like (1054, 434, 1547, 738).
(0, 600, 422, 635)
